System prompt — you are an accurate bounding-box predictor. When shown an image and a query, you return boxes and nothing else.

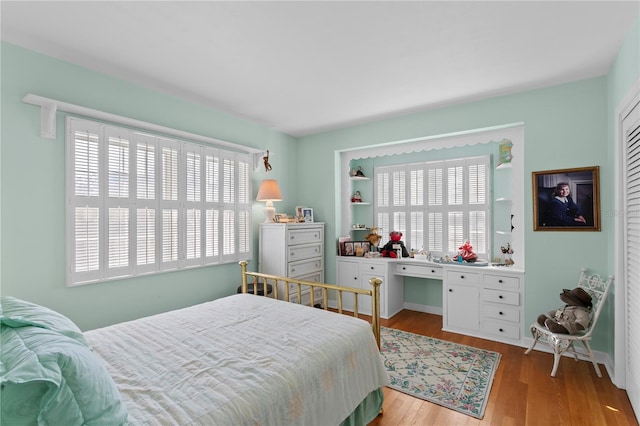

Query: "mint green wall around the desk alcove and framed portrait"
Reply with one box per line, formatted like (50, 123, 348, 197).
(298, 19, 640, 359)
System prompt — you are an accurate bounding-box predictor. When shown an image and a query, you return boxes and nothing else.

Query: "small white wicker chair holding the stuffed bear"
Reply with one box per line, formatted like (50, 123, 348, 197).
(525, 269, 613, 377)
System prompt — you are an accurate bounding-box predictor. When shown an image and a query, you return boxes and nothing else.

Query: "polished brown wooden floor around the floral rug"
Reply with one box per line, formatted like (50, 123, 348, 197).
(370, 310, 638, 426)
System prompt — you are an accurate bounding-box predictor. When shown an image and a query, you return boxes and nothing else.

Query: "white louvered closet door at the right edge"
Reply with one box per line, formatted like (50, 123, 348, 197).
(622, 95, 640, 415)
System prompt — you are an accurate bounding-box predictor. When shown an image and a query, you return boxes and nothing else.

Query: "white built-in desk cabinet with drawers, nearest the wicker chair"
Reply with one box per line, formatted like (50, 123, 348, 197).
(442, 265, 524, 345)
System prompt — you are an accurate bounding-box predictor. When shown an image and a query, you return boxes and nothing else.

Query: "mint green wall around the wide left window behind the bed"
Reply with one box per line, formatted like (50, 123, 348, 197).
(0, 43, 297, 329)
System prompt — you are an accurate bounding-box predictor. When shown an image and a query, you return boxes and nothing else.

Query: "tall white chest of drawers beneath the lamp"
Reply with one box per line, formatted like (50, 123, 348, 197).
(258, 222, 324, 305)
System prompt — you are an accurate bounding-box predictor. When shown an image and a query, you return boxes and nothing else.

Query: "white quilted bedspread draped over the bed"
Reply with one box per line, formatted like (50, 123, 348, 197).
(85, 294, 388, 425)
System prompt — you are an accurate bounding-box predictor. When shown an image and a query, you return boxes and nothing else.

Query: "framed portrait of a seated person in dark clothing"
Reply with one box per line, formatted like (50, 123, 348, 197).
(532, 166, 600, 231)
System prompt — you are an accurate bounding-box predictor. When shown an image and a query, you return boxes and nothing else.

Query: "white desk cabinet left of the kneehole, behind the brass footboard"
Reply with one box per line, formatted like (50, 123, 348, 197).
(336, 256, 404, 319)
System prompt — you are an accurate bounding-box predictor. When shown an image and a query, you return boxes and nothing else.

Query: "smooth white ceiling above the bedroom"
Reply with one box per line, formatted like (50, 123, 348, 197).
(0, 0, 639, 136)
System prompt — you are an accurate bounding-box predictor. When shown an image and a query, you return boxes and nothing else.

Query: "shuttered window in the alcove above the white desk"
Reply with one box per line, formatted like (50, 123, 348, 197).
(374, 156, 491, 258)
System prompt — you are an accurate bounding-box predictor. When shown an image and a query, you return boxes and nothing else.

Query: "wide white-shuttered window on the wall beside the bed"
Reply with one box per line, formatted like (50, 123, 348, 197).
(66, 117, 251, 285)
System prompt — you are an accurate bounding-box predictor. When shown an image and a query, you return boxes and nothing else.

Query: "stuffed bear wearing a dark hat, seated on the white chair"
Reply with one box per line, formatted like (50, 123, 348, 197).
(537, 287, 593, 334)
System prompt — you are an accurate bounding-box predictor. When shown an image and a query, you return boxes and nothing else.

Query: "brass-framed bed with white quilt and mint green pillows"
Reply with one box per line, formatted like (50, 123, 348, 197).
(0, 263, 388, 425)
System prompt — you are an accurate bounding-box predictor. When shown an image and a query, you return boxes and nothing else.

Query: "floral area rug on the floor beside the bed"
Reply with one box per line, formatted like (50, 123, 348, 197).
(380, 327, 501, 419)
